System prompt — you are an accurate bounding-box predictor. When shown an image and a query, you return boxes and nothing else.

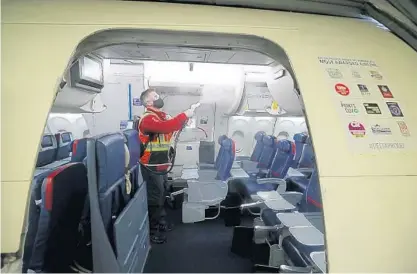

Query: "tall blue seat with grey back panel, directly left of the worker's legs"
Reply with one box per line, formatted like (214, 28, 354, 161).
(94, 132, 150, 273)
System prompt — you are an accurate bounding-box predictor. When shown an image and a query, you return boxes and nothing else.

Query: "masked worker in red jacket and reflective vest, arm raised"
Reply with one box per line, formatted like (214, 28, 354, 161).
(138, 89, 195, 244)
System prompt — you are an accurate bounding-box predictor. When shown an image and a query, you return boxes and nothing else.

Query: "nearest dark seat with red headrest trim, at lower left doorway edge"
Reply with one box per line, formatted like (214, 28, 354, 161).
(22, 163, 88, 273)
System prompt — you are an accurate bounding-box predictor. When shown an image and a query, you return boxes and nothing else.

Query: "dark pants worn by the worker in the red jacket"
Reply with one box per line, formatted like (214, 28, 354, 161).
(141, 167, 166, 227)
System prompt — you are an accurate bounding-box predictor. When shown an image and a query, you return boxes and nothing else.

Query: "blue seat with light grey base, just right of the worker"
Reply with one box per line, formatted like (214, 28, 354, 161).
(182, 138, 235, 223)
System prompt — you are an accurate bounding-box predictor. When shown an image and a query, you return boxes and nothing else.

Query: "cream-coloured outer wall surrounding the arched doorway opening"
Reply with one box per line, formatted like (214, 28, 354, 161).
(1, 1, 417, 273)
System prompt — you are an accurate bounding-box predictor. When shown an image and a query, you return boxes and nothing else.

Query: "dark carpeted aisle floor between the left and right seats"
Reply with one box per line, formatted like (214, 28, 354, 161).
(144, 209, 252, 273)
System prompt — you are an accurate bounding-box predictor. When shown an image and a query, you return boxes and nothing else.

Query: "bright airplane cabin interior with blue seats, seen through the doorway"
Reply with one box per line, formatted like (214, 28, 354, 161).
(4, 28, 326, 273)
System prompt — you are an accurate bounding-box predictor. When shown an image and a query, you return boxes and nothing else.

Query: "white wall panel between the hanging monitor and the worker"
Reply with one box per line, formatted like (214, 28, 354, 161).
(83, 59, 144, 135)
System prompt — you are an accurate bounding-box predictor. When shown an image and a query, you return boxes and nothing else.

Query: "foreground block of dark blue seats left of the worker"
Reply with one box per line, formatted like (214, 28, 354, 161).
(22, 130, 149, 273)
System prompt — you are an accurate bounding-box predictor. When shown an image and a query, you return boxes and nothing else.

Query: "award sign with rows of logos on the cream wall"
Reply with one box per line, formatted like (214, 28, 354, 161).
(318, 57, 417, 154)
